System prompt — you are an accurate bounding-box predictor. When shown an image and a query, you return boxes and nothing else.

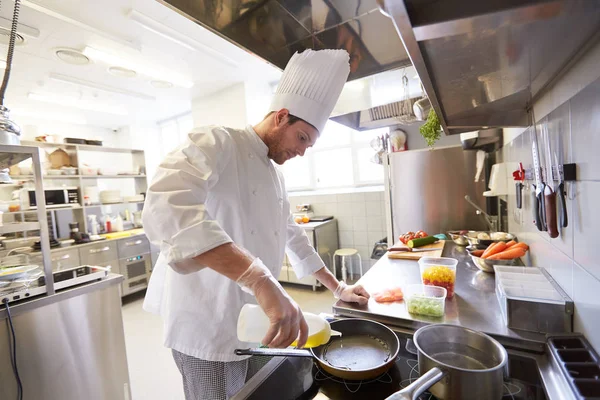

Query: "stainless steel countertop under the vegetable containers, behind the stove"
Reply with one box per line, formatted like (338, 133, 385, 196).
(333, 241, 546, 352)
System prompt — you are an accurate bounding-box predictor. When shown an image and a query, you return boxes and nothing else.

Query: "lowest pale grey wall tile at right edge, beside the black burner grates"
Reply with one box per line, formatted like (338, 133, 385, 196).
(573, 264, 600, 351)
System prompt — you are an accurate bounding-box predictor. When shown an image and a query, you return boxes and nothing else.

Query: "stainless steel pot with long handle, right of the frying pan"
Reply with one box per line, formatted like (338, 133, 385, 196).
(388, 324, 508, 400)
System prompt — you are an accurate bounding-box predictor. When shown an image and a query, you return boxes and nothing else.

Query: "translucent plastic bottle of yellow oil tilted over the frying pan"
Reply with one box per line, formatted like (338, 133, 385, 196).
(237, 304, 342, 348)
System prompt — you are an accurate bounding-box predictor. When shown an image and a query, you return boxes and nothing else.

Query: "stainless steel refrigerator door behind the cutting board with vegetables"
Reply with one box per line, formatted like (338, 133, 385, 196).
(386, 146, 488, 238)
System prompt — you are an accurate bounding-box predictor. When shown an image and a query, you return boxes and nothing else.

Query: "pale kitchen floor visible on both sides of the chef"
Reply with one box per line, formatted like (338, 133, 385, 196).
(123, 285, 335, 400)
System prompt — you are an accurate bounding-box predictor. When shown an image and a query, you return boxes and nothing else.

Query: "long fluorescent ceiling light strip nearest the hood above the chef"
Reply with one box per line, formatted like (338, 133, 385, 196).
(129, 10, 238, 68)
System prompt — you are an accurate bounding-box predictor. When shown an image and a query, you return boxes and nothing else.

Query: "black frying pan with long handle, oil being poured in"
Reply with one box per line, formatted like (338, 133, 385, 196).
(235, 319, 400, 380)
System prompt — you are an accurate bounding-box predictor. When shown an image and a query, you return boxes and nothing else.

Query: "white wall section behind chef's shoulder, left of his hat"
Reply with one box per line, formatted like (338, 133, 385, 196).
(192, 82, 248, 128)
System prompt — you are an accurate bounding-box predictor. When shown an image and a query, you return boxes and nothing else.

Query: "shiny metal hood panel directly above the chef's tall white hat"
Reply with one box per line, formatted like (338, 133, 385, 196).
(159, 0, 410, 80)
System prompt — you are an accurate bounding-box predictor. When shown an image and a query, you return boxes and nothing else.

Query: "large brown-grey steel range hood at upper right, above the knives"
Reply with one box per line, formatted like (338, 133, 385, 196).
(379, 0, 600, 134)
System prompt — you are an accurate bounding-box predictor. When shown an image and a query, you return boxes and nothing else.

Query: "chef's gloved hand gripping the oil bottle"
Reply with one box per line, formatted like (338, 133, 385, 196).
(237, 258, 308, 348)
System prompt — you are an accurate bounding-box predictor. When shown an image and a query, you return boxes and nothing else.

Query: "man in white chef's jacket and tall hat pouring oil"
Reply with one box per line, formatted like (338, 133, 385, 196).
(143, 50, 369, 400)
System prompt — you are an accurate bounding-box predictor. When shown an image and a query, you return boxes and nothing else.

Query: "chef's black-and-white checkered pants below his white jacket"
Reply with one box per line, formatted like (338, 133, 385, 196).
(171, 349, 271, 400)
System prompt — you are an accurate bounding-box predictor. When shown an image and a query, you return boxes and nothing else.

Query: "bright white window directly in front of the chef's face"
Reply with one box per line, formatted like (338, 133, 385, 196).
(281, 121, 389, 191)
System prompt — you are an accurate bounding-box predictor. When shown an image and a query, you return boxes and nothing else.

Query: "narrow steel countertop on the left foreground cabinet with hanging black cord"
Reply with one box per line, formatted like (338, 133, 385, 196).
(0, 273, 124, 320)
